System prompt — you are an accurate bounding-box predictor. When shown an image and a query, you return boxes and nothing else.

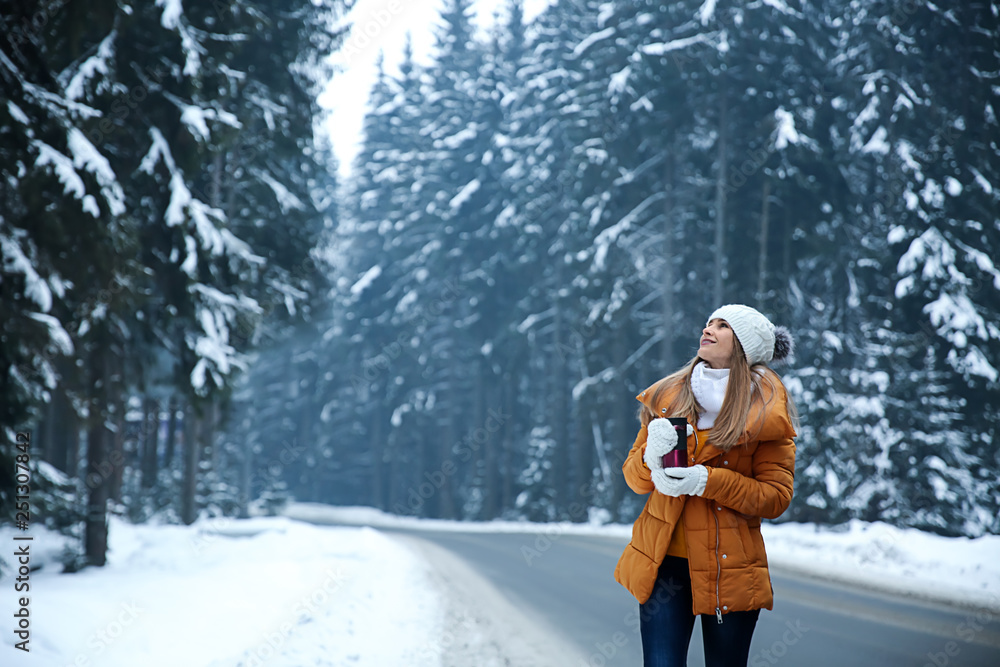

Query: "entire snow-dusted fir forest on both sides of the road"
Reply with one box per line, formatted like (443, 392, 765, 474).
(0, 0, 1000, 569)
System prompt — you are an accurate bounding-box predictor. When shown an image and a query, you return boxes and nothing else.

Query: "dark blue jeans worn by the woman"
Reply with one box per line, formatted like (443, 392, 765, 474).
(639, 556, 760, 667)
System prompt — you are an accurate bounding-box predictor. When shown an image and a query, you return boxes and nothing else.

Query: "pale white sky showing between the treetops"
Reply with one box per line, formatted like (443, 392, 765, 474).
(319, 0, 549, 177)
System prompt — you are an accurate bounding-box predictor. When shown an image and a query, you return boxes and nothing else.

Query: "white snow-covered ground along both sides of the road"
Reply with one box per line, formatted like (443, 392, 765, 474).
(0, 504, 1000, 667)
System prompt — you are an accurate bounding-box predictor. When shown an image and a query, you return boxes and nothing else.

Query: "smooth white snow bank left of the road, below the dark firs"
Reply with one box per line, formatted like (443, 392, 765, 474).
(0, 518, 442, 667)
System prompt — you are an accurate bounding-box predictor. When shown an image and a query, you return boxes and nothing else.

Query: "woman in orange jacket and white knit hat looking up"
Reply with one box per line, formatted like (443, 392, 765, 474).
(615, 305, 796, 667)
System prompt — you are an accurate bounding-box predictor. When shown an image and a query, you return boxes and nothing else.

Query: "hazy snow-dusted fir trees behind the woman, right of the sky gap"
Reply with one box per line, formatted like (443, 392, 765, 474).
(290, 0, 997, 533)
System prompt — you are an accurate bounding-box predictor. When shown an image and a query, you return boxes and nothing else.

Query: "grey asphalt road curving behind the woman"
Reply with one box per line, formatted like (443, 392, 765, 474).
(383, 529, 1000, 667)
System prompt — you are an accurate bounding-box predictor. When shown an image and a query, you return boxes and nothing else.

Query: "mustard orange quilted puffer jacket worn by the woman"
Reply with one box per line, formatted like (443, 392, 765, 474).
(615, 371, 796, 614)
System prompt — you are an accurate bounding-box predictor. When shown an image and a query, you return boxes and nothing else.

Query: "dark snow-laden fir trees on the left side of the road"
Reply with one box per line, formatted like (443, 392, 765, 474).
(0, 0, 344, 564)
